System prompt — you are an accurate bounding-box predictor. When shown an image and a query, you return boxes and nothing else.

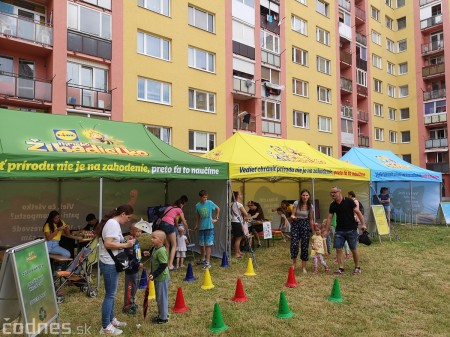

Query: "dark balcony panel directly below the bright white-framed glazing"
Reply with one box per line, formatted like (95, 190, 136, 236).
(67, 30, 112, 60)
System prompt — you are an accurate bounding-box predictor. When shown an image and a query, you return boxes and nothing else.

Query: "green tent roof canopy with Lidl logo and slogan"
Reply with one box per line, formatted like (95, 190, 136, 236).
(0, 109, 228, 179)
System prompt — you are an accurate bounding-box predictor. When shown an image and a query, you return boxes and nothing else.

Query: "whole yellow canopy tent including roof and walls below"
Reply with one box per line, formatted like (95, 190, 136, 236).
(204, 132, 370, 223)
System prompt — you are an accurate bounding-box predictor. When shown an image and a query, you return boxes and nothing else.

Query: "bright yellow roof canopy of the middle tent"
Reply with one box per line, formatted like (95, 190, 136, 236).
(204, 132, 370, 181)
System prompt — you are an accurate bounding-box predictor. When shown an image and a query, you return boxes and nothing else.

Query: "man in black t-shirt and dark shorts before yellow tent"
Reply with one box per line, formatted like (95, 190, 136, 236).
(326, 186, 367, 275)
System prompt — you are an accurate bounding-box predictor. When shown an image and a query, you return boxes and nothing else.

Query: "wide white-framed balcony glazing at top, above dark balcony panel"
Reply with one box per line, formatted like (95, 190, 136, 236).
(67, 3, 112, 40)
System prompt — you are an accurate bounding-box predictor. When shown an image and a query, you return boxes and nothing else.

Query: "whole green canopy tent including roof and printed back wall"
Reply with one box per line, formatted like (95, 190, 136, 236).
(0, 109, 228, 256)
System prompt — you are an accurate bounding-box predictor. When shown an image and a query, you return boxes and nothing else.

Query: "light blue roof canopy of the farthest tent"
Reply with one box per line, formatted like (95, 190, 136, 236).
(341, 147, 442, 182)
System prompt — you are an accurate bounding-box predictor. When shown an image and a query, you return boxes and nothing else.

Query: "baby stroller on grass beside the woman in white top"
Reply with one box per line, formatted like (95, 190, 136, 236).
(53, 238, 99, 303)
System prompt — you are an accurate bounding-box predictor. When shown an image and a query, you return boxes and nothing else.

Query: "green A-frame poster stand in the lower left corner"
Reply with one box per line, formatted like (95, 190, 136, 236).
(0, 239, 61, 337)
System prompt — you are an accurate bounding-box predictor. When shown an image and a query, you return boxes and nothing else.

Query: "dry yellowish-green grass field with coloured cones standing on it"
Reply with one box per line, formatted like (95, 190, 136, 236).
(44, 225, 450, 337)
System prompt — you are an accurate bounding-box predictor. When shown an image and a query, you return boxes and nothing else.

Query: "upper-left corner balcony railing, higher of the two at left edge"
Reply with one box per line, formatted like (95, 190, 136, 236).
(0, 12, 53, 46)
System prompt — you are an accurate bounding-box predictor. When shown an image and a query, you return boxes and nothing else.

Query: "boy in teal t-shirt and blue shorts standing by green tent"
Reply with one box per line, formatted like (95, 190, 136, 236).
(194, 190, 220, 270)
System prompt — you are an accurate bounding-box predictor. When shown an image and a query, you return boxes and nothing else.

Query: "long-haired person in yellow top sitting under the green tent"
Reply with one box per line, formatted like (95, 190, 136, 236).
(42, 210, 70, 257)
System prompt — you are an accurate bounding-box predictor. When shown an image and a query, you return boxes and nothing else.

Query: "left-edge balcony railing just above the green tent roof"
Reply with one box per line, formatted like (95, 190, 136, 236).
(0, 71, 52, 102)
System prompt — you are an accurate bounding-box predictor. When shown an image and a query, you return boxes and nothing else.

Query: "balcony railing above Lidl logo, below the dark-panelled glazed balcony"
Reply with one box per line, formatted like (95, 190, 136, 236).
(66, 83, 112, 111)
